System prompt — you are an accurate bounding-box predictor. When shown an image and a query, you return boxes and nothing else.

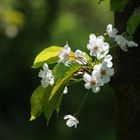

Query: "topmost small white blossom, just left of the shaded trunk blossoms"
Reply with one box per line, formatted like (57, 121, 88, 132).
(106, 24, 118, 38)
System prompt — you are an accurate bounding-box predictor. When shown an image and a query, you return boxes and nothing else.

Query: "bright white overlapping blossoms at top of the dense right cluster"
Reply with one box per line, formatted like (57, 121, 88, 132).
(87, 34, 109, 58)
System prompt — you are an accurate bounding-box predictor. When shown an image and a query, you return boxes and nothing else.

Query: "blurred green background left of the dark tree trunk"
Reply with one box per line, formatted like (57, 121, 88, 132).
(0, 0, 115, 140)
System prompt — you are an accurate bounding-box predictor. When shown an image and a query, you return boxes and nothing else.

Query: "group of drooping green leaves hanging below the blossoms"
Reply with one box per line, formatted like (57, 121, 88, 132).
(30, 61, 81, 122)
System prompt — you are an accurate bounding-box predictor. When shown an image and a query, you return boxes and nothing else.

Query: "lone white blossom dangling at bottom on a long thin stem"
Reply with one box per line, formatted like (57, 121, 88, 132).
(64, 115, 79, 128)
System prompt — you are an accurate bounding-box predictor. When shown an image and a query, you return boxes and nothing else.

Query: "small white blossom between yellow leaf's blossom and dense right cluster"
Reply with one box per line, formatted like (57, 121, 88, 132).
(75, 50, 88, 65)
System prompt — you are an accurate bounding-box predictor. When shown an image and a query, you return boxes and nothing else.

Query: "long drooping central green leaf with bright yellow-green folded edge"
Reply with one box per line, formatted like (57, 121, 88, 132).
(42, 61, 81, 122)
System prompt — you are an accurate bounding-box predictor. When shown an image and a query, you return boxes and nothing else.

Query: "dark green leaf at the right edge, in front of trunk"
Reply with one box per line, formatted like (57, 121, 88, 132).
(126, 8, 140, 35)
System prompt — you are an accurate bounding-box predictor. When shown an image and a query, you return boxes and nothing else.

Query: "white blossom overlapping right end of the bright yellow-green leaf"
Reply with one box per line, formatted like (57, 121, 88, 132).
(58, 44, 71, 63)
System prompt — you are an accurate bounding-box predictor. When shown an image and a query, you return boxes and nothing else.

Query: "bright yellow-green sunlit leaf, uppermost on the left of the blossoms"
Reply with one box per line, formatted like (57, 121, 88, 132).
(32, 46, 63, 68)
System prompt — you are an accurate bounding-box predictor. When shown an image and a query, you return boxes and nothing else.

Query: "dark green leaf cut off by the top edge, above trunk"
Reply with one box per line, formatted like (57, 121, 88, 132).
(110, 0, 129, 12)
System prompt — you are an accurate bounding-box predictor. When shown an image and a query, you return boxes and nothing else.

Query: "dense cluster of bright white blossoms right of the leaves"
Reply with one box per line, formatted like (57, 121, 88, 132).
(83, 34, 114, 93)
